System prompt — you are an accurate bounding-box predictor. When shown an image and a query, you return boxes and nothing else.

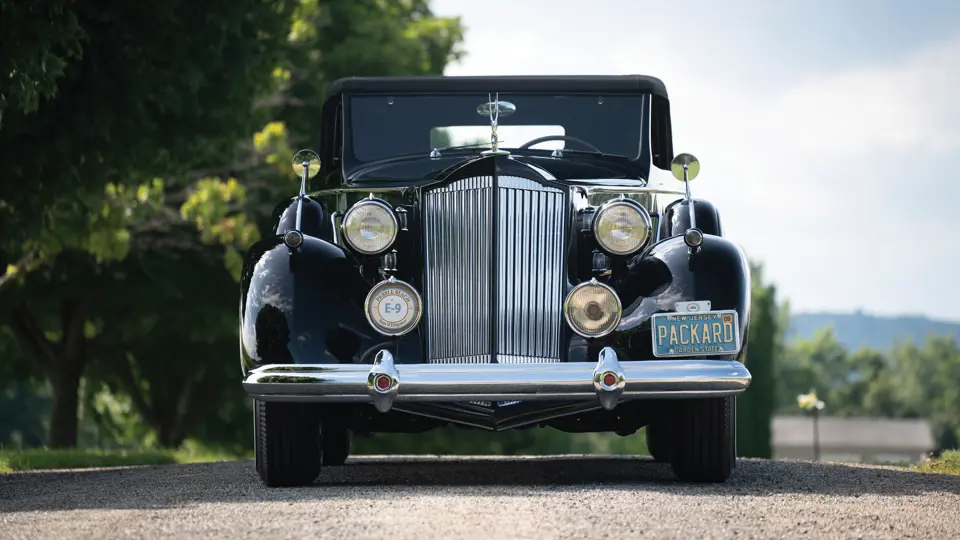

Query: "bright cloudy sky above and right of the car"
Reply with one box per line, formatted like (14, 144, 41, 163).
(431, 0, 960, 321)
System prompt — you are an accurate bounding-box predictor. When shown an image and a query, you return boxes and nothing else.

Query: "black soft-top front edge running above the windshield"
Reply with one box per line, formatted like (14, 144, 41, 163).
(326, 75, 668, 99)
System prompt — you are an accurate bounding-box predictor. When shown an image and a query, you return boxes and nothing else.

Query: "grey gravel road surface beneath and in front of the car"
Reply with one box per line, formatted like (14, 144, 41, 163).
(0, 456, 960, 540)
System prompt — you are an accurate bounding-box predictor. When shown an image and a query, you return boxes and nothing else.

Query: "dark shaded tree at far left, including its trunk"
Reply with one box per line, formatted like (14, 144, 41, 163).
(0, 0, 293, 447)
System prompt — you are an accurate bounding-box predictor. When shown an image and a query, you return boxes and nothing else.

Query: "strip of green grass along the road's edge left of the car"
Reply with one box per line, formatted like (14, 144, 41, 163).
(0, 448, 237, 473)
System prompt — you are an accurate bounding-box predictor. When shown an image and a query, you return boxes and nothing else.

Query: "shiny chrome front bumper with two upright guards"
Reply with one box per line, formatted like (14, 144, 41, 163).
(243, 347, 751, 412)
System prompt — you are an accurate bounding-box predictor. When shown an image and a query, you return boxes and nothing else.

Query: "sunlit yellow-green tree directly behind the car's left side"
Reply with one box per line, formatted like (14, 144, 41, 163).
(81, 0, 460, 448)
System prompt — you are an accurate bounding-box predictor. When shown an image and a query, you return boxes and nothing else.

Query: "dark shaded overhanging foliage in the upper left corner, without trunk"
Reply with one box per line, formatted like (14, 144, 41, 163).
(0, 0, 293, 292)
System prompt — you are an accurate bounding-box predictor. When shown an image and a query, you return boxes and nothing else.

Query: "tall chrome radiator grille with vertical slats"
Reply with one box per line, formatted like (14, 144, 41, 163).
(423, 176, 566, 363)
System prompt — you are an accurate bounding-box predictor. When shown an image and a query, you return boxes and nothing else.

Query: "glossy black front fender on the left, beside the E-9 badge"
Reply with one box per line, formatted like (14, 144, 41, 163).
(240, 235, 422, 372)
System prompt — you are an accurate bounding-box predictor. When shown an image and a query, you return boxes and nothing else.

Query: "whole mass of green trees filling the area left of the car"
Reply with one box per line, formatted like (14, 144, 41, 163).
(0, 0, 461, 452)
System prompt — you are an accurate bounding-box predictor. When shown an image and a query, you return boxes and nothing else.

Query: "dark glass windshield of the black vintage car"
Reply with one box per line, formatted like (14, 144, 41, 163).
(344, 93, 648, 168)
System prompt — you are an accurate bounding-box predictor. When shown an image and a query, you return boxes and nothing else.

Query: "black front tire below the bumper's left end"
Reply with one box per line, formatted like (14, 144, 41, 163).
(253, 400, 323, 487)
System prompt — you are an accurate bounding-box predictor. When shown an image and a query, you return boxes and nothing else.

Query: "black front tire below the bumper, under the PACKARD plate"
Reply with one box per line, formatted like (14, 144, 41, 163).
(670, 396, 737, 482)
